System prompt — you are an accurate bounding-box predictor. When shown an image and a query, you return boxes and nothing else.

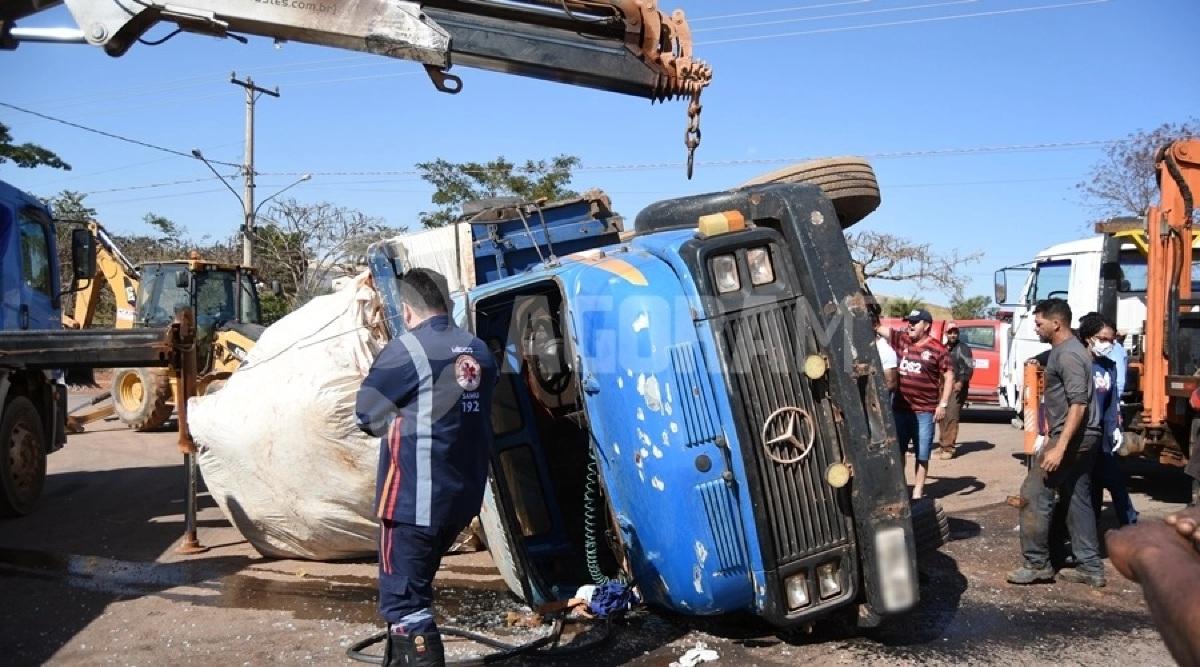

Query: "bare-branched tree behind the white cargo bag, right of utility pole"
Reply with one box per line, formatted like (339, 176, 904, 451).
(254, 199, 403, 307)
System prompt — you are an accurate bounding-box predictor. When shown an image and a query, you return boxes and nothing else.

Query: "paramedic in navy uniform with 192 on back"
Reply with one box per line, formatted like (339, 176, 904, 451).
(355, 269, 497, 666)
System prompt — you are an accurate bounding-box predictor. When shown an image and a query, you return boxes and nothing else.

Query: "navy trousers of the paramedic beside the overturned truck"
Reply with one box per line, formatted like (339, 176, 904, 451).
(379, 519, 466, 633)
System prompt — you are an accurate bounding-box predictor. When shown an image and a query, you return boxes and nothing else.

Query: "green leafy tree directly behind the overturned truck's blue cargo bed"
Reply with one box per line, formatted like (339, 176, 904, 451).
(416, 155, 580, 227)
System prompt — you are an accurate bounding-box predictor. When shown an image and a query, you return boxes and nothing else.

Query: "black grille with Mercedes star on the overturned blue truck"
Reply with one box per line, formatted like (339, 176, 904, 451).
(714, 300, 851, 566)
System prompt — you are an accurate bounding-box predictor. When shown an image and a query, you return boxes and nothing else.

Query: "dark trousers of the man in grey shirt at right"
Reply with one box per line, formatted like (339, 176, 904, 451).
(1021, 435, 1104, 575)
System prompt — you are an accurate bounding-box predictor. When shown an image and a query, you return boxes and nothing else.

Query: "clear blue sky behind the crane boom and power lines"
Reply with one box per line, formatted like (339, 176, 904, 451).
(0, 0, 1200, 302)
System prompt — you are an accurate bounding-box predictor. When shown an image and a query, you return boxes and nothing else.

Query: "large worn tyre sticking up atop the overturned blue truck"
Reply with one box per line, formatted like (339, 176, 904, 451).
(739, 157, 882, 229)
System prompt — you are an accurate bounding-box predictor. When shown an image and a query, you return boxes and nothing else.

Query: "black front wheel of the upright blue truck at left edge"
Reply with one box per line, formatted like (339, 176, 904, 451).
(0, 396, 47, 516)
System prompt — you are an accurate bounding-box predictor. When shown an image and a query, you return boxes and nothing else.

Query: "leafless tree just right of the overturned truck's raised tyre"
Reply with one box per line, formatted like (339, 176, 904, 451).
(846, 232, 983, 294)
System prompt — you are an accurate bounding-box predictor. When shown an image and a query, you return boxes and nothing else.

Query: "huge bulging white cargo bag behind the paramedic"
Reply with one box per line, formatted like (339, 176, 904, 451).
(188, 274, 386, 560)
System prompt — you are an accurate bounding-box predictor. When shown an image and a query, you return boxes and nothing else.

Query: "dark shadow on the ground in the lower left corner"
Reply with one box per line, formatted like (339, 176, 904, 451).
(0, 464, 250, 665)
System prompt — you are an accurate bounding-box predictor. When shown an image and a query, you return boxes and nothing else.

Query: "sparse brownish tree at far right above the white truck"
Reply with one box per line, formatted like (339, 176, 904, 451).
(1075, 118, 1200, 220)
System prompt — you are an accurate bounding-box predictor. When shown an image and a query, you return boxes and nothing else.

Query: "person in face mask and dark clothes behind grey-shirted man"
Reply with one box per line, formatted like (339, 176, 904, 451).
(1078, 313, 1138, 525)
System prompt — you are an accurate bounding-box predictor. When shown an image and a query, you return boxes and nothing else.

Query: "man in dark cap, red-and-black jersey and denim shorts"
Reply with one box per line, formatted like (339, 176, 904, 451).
(880, 308, 954, 500)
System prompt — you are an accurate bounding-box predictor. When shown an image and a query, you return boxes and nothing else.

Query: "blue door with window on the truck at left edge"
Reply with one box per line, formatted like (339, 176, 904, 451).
(13, 208, 62, 329)
